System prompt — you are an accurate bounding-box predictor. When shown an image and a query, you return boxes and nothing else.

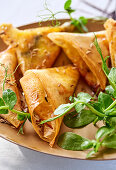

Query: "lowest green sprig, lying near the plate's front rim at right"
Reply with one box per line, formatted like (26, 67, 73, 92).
(58, 126, 116, 158)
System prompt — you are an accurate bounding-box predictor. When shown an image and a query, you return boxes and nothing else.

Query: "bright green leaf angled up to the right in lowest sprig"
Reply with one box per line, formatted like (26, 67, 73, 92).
(95, 126, 115, 140)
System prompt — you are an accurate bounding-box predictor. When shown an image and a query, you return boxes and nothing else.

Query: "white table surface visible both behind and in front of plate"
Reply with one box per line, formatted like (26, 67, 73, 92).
(0, 0, 116, 170)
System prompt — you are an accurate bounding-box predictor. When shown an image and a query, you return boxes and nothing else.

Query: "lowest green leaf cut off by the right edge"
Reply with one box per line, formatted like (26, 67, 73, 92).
(102, 134, 116, 149)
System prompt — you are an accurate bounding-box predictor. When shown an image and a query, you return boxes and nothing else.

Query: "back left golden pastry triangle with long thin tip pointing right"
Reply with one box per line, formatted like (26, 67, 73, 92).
(0, 24, 72, 74)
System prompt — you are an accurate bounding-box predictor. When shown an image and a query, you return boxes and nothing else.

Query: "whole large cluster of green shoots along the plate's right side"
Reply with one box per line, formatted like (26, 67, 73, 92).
(41, 35, 116, 158)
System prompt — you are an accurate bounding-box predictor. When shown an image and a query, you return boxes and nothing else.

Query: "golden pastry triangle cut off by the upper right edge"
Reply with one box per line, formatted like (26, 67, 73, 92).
(104, 18, 116, 67)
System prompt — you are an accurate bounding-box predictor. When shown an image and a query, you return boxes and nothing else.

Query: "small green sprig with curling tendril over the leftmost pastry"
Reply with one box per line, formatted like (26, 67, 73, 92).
(0, 63, 31, 134)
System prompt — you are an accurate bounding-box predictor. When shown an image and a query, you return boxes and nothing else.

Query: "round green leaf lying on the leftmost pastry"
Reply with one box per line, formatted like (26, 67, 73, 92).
(2, 89, 17, 110)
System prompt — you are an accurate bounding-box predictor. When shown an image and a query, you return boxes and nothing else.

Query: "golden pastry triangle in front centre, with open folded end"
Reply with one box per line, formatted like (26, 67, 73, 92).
(20, 66, 79, 146)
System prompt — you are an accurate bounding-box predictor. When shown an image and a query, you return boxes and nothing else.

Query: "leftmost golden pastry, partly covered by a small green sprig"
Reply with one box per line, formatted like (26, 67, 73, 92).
(0, 48, 21, 128)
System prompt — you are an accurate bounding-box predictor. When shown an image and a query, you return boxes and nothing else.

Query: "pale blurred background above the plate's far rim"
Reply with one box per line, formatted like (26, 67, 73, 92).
(0, 0, 116, 26)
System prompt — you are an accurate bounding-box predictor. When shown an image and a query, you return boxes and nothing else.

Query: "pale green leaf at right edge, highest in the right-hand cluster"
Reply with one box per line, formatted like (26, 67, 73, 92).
(108, 67, 116, 86)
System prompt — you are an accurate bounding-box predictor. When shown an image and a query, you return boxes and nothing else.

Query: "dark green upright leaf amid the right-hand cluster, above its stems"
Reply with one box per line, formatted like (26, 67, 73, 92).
(98, 92, 113, 109)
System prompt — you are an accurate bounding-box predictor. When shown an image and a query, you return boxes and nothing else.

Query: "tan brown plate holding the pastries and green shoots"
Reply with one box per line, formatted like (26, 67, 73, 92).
(0, 20, 116, 160)
